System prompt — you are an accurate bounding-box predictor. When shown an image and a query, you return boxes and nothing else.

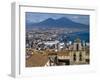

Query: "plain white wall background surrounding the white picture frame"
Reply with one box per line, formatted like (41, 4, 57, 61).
(0, 0, 100, 80)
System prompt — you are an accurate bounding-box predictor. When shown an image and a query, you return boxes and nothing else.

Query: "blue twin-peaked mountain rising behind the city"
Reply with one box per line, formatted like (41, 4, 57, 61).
(26, 17, 89, 29)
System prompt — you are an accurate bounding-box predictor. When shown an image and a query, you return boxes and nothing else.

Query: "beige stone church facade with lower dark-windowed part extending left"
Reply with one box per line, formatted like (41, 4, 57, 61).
(46, 38, 89, 66)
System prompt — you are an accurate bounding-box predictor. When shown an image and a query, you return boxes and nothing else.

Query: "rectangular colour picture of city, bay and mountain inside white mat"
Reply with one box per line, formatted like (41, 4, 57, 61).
(25, 12, 90, 67)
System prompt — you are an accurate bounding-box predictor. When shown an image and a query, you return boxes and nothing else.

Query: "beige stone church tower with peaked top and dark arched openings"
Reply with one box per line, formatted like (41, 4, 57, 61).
(70, 38, 86, 64)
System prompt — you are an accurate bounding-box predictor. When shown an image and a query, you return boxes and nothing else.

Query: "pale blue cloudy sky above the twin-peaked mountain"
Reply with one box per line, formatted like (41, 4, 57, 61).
(25, 12, 89, 25)
